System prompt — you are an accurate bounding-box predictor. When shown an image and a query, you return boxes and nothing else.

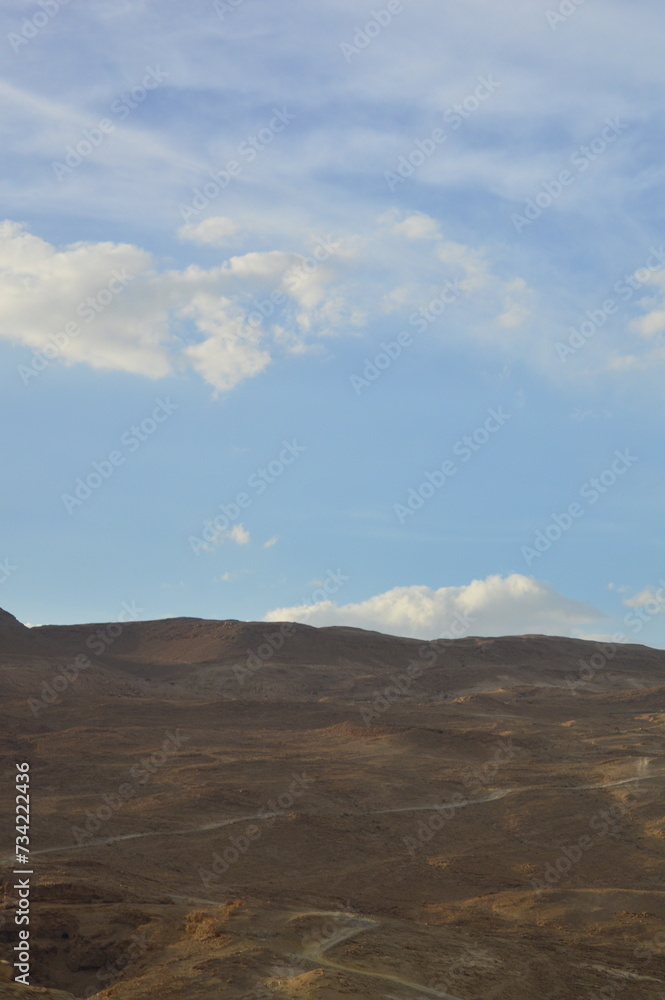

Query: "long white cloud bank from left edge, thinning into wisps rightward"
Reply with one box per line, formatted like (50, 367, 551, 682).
(0, 221, 528, 392)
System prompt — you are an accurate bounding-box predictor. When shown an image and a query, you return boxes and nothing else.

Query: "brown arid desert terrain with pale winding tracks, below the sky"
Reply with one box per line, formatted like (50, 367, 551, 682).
(0, 600, 665, 1000)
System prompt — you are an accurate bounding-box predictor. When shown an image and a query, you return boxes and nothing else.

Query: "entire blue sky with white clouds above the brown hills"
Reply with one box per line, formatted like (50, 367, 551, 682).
(0, 0, 665, 647)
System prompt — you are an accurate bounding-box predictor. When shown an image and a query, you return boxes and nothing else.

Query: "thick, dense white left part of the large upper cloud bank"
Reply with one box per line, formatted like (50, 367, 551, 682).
(0, 221, 336, 391)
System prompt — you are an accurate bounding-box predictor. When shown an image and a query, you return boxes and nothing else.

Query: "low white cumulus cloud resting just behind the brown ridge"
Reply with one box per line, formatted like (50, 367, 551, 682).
(265, 573, 604, 639)
